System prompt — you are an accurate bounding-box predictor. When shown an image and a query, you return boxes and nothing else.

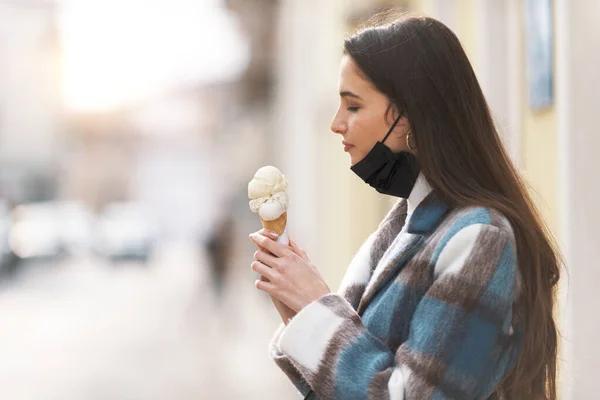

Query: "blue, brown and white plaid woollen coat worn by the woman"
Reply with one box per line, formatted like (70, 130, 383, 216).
(270, 192, 521, 400)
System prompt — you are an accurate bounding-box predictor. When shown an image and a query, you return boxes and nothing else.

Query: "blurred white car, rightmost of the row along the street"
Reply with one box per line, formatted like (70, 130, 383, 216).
(96, 202, 156, 263)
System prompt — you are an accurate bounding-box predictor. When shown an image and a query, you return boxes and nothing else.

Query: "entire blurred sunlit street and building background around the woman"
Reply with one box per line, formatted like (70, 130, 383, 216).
(0, 0, 600, 400)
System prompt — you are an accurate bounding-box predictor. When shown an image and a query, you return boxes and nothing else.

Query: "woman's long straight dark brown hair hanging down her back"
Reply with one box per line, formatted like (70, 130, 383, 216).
(344, 16, 561, 400)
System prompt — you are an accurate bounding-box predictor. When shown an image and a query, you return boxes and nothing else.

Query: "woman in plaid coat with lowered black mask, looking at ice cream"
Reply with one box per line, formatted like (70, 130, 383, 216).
(250, 17, 559, 400)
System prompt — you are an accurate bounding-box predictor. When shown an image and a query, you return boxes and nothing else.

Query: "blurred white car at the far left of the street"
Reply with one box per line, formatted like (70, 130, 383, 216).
(9, 202, 66, 259)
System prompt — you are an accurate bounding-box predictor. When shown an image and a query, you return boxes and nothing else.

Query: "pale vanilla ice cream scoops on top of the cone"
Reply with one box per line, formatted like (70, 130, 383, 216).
(248, 165, 289, 221)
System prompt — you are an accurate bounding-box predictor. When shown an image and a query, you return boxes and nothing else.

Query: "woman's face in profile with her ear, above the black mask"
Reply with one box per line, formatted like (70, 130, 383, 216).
(331, 56, 410, 165)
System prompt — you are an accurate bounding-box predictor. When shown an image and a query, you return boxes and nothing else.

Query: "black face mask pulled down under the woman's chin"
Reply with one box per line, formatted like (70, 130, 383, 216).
(350, 116, 421, 199)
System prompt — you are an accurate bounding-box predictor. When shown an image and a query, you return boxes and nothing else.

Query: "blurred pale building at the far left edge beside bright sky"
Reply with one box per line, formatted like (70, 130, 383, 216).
(0, 1, 62, 202)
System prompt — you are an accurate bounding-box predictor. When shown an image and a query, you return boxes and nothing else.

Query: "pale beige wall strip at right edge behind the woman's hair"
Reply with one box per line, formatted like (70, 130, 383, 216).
(555, 0, 600, 399)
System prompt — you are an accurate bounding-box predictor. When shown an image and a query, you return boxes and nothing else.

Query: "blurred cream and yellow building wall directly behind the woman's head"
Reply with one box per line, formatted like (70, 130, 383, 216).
(269, 0, 600, 399)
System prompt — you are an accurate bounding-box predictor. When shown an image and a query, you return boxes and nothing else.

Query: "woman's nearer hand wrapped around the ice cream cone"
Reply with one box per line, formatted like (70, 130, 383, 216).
(250, 233, 331, 312)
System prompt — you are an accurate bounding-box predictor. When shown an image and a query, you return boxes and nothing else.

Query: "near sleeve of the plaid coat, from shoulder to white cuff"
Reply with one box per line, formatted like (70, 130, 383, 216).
(275, 224, 517, 400)
